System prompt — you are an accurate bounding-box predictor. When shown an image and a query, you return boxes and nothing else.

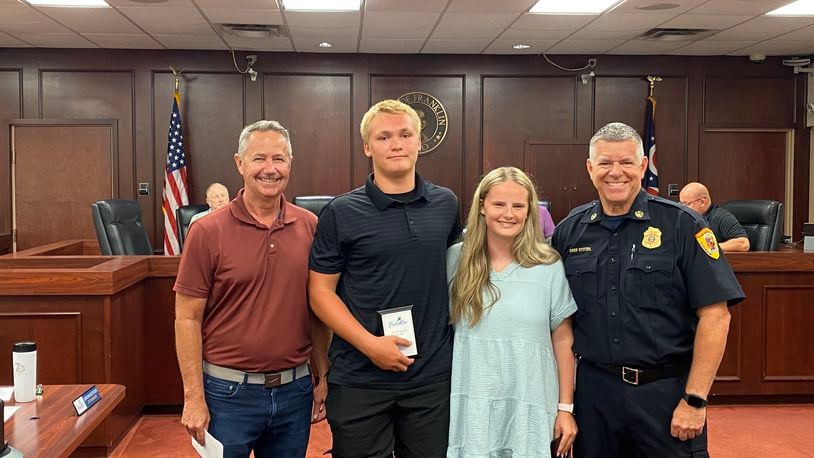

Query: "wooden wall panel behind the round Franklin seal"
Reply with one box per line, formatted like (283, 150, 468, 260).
(370, 75, 468, 199)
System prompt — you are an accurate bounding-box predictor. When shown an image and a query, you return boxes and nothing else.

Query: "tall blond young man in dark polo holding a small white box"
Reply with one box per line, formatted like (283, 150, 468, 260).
(308, 100, 460, 458)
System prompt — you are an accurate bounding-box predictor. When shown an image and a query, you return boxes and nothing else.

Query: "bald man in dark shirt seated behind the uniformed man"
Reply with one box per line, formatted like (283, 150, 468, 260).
(678, 182, 749, 251)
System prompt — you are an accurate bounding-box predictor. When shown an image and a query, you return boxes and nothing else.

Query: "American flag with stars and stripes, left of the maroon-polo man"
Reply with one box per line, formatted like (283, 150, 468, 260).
(162, 91, 189, 256)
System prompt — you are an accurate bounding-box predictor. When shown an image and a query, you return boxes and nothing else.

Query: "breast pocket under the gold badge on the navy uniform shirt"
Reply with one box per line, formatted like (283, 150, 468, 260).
(624, 255, 675, 309)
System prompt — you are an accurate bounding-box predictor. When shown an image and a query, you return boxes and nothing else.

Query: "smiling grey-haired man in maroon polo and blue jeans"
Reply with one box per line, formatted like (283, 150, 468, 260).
(174, 121, 329, 458)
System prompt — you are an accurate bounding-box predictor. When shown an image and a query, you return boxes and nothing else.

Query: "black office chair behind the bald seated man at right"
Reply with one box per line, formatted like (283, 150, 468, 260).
(720, 200, 784, 251)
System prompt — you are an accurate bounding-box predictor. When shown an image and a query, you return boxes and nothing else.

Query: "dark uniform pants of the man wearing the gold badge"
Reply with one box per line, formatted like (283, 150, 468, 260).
(574, 361, 709, 458)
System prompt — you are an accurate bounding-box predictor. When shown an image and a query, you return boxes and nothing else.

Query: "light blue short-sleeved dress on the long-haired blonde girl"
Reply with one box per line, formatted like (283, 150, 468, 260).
(447, 243, 577, 457)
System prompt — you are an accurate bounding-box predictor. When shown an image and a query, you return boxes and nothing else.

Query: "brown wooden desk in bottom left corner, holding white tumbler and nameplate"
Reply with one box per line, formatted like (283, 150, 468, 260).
(6, 385, 124, 458)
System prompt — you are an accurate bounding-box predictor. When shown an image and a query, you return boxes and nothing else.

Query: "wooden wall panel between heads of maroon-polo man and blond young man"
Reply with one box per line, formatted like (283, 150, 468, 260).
(263, 74, 354, 200)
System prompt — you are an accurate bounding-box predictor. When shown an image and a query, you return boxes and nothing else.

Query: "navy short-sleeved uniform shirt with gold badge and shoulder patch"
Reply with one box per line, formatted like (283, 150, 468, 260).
(552, 191, 745, 368)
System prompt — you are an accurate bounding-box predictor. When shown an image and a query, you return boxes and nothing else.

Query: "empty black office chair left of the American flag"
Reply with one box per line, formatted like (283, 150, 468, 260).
(91, 199, 153, 256)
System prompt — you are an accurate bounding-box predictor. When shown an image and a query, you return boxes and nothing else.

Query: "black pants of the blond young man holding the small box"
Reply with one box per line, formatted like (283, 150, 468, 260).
(325, 380, 450, 458)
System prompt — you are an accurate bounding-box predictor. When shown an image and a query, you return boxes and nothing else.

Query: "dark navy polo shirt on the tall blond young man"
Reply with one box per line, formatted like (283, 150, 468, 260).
(309, 174, 460, 388)
